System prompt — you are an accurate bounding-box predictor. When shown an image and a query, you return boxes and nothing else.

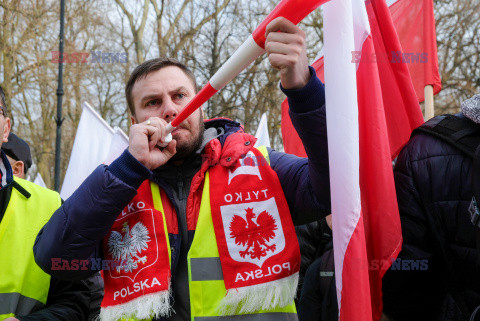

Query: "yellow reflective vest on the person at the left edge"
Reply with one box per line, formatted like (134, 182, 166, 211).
(0, 178, 61, 320)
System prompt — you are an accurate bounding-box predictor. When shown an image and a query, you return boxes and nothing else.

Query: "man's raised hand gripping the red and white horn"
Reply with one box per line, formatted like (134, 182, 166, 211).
(265, 17, 310, 89)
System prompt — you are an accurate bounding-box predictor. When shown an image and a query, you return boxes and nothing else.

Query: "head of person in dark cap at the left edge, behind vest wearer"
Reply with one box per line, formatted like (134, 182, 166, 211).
(2, 132, 32, 179)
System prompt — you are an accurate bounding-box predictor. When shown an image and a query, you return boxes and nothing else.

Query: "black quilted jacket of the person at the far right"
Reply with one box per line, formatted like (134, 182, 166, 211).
(383, 114, 480, 321)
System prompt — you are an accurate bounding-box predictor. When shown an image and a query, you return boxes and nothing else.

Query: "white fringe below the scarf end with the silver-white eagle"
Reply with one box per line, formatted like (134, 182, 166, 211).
(97, 284, 173, 321)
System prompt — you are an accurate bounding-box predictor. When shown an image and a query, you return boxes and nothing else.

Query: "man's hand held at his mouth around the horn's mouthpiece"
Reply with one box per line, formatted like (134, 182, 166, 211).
(128, 117, 177, 170)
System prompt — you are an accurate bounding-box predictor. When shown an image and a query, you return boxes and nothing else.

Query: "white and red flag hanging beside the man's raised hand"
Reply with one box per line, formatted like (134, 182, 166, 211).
(324, 0, 423, 321)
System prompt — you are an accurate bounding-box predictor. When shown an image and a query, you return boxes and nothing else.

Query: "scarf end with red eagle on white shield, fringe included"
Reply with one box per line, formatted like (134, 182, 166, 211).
(209, 149, 300, 314)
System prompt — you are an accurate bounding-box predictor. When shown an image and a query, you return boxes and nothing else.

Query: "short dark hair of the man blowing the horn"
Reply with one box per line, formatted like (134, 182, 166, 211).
(125, 57, 197, 116)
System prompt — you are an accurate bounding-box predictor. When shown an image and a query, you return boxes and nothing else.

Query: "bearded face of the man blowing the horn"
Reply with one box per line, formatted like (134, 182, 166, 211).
(132, 66, 204, 160)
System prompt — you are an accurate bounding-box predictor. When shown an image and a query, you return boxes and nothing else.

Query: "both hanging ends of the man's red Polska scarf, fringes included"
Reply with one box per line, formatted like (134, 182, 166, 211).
(100, 149, 300, 321)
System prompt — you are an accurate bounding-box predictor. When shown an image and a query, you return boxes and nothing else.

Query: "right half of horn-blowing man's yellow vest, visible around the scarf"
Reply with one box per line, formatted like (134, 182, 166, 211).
(188, 147, 298, 321)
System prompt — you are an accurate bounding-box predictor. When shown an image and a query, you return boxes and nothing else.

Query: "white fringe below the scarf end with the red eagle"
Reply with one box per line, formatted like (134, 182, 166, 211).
(218, 272, 298, 315)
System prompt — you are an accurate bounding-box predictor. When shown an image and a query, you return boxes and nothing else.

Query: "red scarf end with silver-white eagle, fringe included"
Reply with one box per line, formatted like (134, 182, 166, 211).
(100, 180, 171, 321)
